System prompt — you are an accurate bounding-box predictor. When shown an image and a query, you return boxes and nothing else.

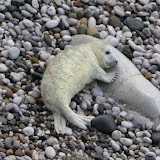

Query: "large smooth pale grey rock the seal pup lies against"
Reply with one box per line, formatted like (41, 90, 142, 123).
(71, 35, 160, 123)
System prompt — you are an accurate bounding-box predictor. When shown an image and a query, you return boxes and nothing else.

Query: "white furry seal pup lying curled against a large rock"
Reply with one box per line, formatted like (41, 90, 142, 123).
(41, 41, 118, 134)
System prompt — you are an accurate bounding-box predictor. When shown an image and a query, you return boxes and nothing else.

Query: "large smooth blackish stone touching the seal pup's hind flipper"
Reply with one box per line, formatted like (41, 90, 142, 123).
(91, 115, 117, 134)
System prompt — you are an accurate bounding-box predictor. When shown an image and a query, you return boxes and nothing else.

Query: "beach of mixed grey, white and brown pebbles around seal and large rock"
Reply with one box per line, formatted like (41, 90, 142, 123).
(0, 0, 160, 160)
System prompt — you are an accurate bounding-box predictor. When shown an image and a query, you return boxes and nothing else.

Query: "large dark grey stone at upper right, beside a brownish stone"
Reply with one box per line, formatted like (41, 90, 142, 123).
(125, 17, 144, 31)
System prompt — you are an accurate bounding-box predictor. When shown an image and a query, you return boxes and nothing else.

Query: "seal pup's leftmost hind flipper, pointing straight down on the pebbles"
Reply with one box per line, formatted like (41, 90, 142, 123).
(53, 113, 66, 134)
